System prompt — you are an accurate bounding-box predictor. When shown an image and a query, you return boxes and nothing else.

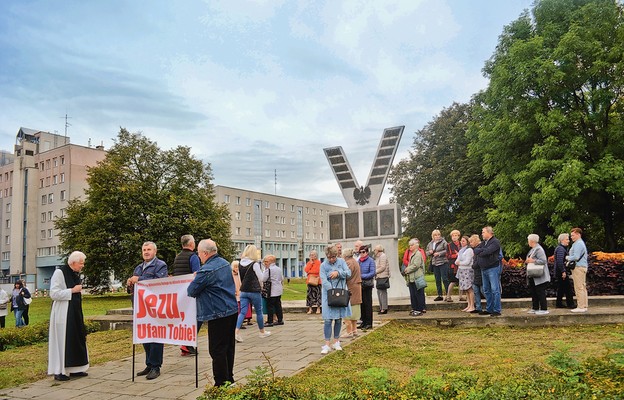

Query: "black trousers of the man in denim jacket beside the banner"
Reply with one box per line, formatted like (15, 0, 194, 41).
(208, 314, 238, 386)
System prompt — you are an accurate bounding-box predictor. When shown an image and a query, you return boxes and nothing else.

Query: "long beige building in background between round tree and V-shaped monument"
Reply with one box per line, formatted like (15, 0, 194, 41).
(215, 186, 345, 277)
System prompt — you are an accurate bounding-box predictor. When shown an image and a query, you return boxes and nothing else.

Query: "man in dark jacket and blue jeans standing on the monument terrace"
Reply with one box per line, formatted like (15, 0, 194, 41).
(474, 226, 502, 317)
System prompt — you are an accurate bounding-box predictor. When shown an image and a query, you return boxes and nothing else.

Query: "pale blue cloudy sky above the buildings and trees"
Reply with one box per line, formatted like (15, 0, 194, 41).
(0, 0, 532, 205)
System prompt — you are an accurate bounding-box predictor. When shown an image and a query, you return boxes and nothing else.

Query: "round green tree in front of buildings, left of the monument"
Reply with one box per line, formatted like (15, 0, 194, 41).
(55, 128, 233, 288)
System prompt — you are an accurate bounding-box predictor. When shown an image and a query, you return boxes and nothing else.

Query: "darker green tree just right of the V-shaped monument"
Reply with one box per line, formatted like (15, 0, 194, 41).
(390, 103, 485, 244)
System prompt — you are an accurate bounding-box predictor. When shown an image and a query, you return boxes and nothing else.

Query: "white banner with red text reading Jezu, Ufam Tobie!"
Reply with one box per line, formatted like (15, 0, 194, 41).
(132, 274, 197, 346)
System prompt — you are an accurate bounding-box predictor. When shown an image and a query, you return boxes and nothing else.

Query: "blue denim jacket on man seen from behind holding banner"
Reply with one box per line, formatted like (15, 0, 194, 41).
(186, 254, 238, 321)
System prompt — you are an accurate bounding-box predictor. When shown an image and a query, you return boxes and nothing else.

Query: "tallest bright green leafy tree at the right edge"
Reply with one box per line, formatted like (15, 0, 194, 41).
(470, 0, 624, 254)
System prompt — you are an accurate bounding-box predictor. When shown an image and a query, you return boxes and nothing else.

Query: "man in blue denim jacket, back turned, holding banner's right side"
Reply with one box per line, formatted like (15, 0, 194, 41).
(187, 239, 238, 386)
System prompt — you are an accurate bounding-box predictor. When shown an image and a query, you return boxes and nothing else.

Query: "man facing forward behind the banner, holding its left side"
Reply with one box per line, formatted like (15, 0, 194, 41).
(127, 242, 168, 380)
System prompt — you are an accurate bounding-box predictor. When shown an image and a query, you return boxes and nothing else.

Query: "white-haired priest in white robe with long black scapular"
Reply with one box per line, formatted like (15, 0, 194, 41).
(48, 251, 89, 381)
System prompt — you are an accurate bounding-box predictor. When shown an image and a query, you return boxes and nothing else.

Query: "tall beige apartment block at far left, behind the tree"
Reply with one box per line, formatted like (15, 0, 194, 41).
(0, 128, 106, 289)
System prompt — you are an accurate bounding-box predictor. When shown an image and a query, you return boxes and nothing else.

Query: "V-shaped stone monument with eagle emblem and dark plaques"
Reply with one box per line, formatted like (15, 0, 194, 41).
(323, 126, 409, 299)
